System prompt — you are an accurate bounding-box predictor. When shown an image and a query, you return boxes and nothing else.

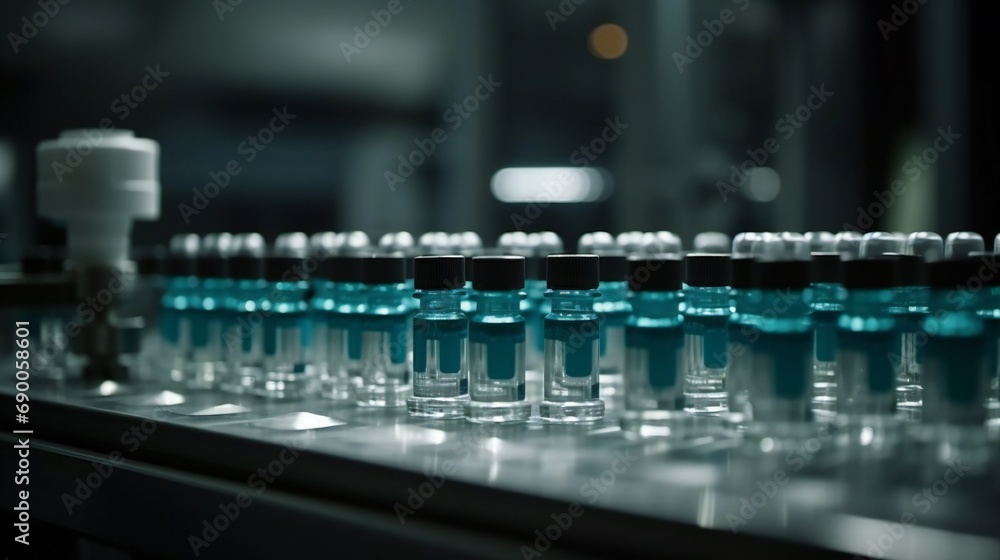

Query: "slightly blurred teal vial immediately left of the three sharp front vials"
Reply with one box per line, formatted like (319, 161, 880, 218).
(357, 256, 413, 407)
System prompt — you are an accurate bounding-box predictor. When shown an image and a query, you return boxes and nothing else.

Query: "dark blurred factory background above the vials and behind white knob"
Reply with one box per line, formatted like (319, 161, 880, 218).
(0, 0, 1000, 261)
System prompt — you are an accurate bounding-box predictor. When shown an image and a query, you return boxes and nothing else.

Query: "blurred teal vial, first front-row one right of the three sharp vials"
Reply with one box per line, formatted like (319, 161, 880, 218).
(622, 254, 687, 436)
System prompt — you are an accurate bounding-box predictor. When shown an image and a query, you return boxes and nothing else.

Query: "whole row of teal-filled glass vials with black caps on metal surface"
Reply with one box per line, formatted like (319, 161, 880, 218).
(19, 232, 1000, 445)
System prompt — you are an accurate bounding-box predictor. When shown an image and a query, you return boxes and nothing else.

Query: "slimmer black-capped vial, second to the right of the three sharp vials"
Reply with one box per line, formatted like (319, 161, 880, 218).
(684, 253, 732, 415)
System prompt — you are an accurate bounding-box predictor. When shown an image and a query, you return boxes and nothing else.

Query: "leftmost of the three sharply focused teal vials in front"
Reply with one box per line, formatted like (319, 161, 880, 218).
(407, 255, 469, 418)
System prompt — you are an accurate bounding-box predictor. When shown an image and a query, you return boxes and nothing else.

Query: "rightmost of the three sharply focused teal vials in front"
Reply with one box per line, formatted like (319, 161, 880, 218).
(539, 255, 604, 423)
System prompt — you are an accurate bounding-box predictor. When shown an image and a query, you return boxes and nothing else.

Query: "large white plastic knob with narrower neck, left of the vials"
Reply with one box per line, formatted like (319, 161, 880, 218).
(37, 128, 160, 268)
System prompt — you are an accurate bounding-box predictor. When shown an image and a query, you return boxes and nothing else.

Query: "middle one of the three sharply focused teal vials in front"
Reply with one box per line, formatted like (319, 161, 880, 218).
(466, 256, 531, 422)
